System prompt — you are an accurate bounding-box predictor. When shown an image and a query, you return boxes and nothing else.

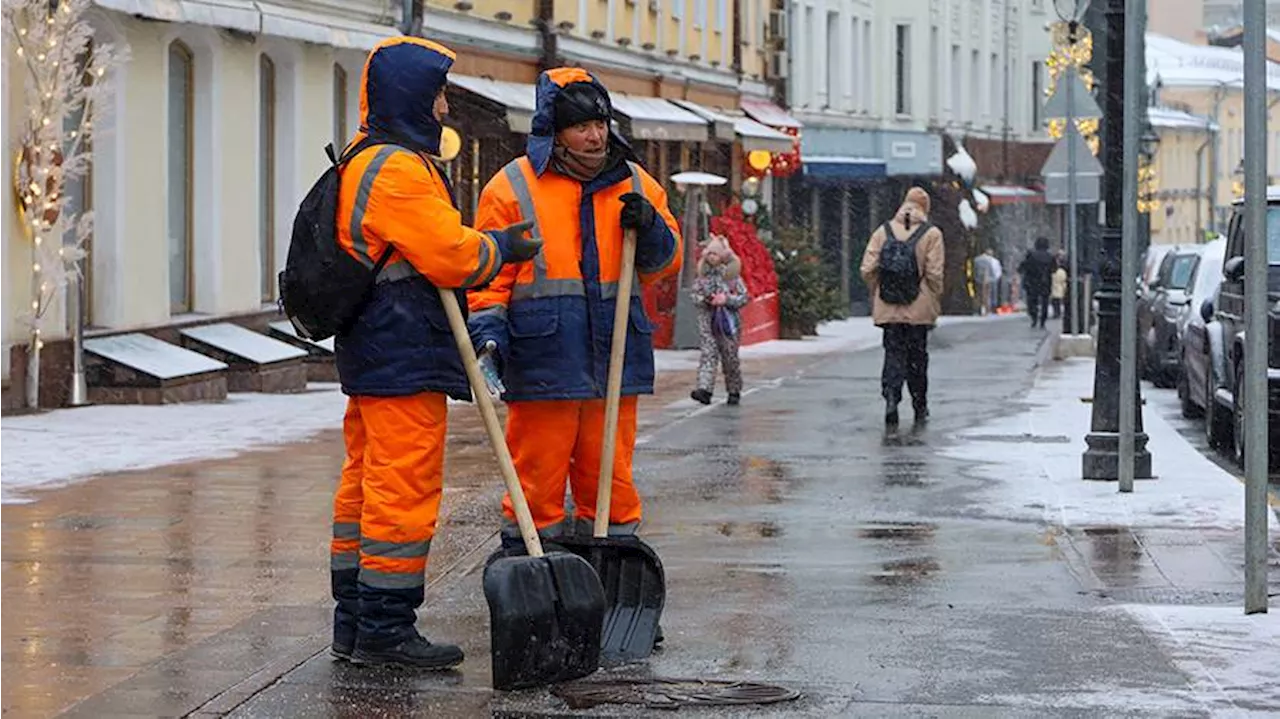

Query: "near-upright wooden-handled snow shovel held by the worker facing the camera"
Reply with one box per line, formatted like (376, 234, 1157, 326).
(559, 230, 667, 664)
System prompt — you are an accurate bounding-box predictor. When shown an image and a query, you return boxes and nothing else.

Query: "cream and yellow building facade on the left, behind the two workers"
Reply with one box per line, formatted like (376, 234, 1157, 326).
(0, 0, 794, 409)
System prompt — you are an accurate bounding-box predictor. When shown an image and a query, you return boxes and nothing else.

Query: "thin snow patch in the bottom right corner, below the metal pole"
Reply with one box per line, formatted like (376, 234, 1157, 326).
(1106, 604, 1280, 716)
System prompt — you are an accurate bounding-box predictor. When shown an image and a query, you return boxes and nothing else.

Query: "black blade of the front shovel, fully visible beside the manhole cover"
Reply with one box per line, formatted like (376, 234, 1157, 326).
(484, 553, 605, 690)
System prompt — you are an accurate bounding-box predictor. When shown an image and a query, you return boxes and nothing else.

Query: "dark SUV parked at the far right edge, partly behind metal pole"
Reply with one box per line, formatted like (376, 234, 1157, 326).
(1201, 187, 1280, 464)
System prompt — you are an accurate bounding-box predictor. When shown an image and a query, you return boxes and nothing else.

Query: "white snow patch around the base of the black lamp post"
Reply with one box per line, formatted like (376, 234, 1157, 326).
(943, 358, 1269, 530)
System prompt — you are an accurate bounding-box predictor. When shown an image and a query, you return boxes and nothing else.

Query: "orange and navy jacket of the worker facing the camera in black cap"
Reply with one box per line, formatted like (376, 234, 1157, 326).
(468, 68, 682, 402)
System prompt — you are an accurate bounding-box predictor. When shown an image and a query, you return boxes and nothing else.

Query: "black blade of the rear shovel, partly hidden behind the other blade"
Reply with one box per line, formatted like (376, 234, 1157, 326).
(557, 536, 667, 664)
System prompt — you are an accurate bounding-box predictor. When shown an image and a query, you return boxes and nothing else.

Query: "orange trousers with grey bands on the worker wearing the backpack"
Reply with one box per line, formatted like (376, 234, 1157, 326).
(330, 393, 447, 593)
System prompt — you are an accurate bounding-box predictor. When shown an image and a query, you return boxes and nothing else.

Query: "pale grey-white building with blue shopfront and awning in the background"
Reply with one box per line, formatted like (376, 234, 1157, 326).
(787, 0, 1051, 310)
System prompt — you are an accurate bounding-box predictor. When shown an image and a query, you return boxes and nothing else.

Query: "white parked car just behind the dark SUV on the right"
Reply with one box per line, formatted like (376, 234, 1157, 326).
(1178, 238, 1226, 418)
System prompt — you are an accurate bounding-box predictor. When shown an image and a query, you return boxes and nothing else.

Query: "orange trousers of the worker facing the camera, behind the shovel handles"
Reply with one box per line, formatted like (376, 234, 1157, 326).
(502, 397, 641, 537)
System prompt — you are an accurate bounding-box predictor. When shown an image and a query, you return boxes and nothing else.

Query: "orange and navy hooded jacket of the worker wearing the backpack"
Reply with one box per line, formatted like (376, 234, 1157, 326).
(335, 37, 507, 399)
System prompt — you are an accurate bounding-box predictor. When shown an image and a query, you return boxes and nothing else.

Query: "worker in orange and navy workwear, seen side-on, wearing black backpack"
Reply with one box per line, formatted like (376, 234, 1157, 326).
(330, 37, 540, 669)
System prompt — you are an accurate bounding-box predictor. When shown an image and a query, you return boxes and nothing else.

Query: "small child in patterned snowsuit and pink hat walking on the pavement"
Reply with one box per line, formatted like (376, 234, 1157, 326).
(690, 234, 750, 404)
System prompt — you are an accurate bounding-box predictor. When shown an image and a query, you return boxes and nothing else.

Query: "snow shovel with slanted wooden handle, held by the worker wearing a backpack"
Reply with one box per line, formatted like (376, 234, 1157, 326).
(440, 289, 605, 690)
